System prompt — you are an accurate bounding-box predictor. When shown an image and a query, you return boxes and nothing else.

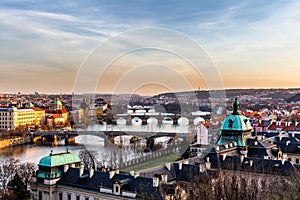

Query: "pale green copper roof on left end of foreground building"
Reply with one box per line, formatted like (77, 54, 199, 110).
(39, 152, 81, 167)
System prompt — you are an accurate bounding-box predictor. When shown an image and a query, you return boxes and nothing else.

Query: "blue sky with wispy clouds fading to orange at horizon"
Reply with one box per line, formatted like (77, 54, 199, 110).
(0, 0, 300, 95)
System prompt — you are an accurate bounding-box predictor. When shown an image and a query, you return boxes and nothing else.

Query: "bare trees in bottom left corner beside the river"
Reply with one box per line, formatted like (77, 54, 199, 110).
(0, 158, 36, 200)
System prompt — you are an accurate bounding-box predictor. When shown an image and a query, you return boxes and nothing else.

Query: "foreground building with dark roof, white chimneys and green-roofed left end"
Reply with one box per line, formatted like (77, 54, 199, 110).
(31, 151, 162, 200)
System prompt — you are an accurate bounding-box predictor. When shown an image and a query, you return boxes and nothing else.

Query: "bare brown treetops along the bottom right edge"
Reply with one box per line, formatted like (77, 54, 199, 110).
(173, 170, 300, 200)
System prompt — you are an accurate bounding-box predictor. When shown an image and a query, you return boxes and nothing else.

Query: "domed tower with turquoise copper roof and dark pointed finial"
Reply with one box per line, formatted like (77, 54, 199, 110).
(217, 98, 253, 147)
